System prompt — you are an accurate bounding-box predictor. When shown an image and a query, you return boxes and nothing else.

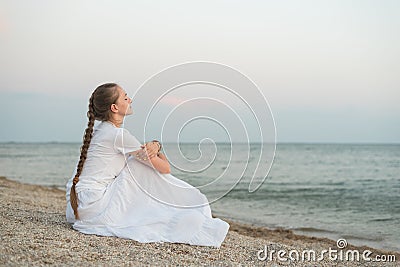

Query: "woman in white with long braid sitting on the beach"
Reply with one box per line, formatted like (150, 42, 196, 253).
(66, 83, 229, 247)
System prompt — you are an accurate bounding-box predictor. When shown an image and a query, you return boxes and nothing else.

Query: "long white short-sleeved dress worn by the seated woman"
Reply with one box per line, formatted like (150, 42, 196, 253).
(66, 122, 229, 247)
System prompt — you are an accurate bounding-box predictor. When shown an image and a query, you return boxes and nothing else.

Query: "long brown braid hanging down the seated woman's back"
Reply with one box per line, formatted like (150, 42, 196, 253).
(70, 92, 95, 219)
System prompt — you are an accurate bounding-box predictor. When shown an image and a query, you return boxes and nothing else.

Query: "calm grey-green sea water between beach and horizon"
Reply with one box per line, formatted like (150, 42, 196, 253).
(0, 143, 400, 251)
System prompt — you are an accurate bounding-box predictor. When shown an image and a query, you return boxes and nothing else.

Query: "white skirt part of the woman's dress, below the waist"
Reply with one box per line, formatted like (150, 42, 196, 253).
(66, 157, 229, 247)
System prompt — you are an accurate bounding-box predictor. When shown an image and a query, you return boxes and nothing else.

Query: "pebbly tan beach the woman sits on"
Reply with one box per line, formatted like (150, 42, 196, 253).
(0, 177, 400, 266)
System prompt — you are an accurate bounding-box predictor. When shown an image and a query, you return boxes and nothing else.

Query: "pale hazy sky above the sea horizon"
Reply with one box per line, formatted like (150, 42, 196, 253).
(0, 0, 400, 143)
